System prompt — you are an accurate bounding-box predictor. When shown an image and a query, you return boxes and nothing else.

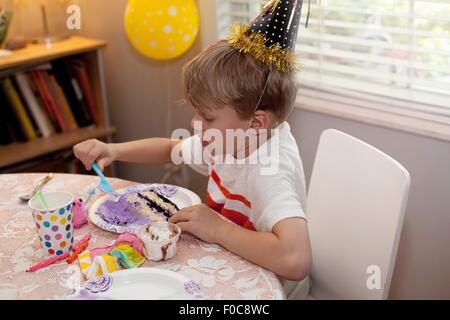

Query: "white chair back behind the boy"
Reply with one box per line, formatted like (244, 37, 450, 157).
(307, 129, 410, 299)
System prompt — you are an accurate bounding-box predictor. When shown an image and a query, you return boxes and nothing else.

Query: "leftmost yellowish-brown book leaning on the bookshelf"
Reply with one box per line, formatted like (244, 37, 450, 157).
(1, 78, 37, 140)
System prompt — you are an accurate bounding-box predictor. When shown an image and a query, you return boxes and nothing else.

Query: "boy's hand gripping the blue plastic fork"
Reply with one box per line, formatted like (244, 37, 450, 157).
(73, 139, 117, 171)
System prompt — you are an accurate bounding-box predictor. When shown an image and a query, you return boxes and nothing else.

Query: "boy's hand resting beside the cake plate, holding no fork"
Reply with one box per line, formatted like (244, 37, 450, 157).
(169, 203, 228, 243)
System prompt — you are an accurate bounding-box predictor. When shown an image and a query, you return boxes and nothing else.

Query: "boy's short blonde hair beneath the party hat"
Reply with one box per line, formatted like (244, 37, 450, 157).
(183, 40, 298, 121)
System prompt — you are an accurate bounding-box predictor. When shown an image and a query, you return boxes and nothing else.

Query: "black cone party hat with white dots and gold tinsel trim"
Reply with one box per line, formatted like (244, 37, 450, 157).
(228, 0, 309, 72)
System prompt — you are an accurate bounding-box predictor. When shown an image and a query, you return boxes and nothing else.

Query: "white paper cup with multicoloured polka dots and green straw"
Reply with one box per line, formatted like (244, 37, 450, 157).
(28, 192, 73, 256)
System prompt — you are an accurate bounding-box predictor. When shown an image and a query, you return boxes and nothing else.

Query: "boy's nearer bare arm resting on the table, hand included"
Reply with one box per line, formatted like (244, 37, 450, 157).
(169, 204, 311, 280)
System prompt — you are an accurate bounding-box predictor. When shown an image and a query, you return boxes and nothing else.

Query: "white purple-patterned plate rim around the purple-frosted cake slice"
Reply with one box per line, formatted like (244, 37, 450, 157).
(89, 183, 201, 233)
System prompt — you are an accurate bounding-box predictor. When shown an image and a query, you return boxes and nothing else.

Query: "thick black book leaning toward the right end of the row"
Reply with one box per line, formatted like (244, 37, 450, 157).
(52, 59, 93, 127)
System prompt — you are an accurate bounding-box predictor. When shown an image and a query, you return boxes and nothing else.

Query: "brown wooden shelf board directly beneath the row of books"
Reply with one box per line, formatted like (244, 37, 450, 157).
(0, 127, 116, 168)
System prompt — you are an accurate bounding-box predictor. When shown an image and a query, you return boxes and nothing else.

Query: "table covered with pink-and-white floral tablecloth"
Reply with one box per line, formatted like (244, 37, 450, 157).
(0, 173, 285, 300)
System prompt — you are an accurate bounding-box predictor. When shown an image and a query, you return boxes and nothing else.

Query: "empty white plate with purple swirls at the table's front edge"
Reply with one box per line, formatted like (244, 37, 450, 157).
(68, 268, 203, 300)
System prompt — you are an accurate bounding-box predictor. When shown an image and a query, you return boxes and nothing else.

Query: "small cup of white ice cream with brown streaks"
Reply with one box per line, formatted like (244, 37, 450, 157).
(136, 221, 181, 261)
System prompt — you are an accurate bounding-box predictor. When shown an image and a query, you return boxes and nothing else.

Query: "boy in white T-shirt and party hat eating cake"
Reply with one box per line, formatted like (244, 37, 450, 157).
(74, 0, 311, 296)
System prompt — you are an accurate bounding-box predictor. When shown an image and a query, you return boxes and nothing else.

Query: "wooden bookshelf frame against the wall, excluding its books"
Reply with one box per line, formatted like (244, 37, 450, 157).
(0, 37, 116, 173)
